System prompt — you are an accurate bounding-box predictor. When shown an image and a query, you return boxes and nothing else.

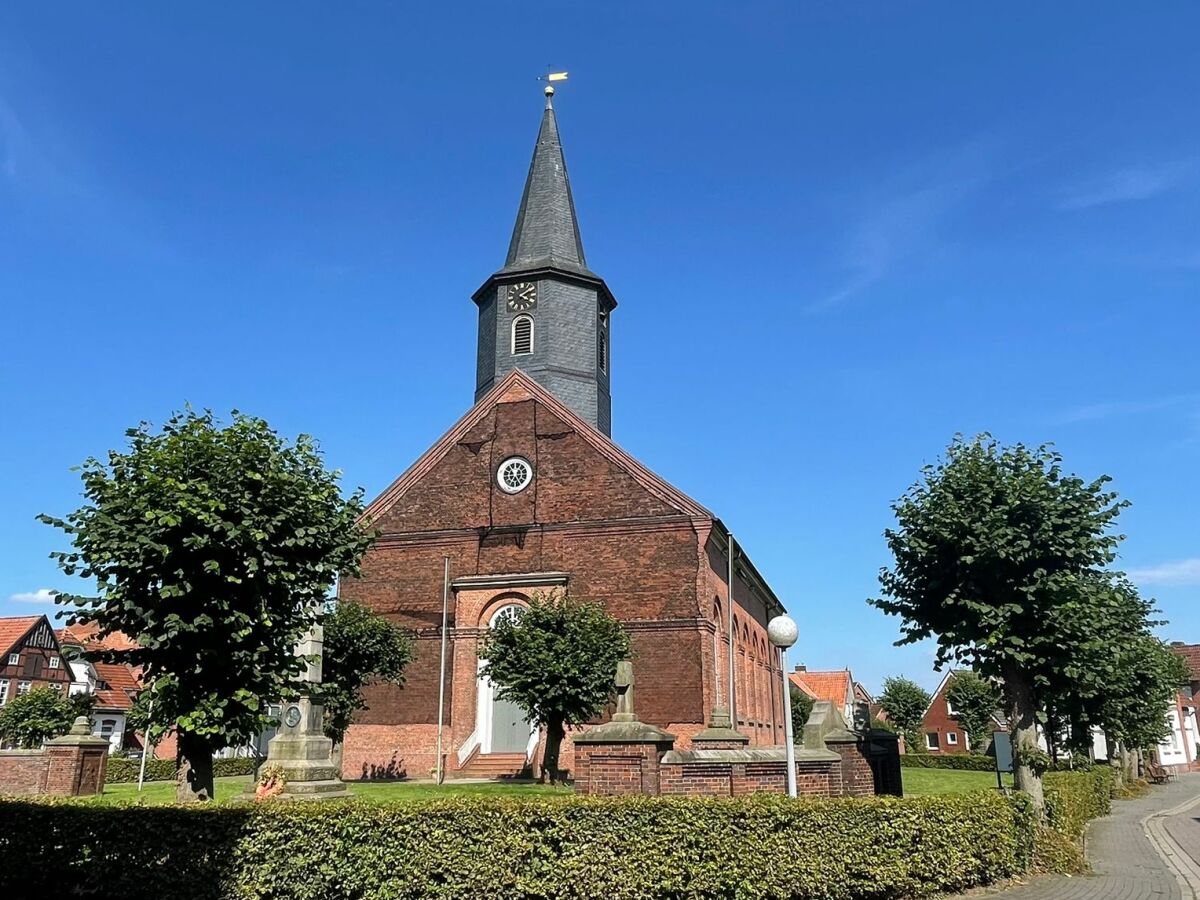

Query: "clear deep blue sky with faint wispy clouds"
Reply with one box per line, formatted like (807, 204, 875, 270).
(0, 0, 1200, 688)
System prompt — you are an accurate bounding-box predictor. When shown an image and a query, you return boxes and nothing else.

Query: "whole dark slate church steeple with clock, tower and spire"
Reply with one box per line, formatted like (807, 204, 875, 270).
(472, 86, 617, 434)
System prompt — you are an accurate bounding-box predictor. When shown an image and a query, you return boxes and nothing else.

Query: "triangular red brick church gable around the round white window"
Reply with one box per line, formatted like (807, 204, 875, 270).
(367, 372, 708, 534)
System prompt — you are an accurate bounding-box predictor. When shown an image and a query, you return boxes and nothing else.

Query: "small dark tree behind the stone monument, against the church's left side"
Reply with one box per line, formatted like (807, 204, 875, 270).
(320, 601, 413, 745)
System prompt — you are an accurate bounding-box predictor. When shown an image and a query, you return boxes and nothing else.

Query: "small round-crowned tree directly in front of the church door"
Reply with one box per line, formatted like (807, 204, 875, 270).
(479, 594, 629, 782)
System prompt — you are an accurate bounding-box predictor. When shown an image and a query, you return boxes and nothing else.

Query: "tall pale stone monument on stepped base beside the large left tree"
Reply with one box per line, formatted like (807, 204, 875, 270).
(247, 625, 350, 800)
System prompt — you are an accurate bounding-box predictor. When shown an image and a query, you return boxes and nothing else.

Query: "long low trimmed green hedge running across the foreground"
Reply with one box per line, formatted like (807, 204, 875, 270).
(0, 792, 1032, 900)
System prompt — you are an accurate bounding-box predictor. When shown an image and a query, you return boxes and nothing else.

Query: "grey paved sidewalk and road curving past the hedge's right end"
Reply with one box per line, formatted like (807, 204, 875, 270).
(945, 774, 1200, 900)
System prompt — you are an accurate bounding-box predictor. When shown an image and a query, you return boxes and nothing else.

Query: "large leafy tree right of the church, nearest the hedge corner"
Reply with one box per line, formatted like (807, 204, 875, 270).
(870, 434, 1127, 812)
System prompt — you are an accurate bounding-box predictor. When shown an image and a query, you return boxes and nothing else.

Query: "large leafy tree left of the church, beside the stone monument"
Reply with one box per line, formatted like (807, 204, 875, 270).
(40, 410, 373, 800)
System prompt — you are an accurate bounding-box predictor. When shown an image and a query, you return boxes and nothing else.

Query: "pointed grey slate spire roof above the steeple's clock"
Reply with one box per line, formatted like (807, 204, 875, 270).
(500, 96, 590, 275)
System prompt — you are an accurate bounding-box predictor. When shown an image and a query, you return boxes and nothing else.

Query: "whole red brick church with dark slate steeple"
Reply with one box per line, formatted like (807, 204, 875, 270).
(340, 89, 784, 779)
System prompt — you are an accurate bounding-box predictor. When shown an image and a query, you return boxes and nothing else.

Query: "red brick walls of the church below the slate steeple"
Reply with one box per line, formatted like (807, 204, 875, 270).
(340, 400, 782, 778)
